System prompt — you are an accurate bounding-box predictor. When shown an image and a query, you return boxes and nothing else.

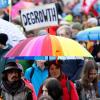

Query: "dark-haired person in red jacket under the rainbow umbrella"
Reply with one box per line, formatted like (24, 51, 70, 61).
(38, 60, 79, 100)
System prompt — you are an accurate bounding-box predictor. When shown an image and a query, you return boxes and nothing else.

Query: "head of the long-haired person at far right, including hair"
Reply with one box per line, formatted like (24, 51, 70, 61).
(82, 60, 98, 89)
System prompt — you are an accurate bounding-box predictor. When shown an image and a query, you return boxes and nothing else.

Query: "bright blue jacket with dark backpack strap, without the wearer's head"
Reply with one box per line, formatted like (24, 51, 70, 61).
(25, 64, 48, 95)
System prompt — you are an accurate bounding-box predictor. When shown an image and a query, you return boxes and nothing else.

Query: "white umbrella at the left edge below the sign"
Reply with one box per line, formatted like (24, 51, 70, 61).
(0, 18, 26, 46)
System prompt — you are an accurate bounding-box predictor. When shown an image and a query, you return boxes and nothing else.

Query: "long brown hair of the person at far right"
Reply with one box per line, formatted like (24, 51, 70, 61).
(82, 60, 98, 90)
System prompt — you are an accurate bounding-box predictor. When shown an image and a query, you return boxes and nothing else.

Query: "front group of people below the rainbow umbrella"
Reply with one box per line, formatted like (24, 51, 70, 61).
(0, 60, 99, 100)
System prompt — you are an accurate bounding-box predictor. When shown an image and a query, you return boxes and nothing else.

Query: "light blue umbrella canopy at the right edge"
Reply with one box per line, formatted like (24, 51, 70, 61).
(76, 27, 100, 41)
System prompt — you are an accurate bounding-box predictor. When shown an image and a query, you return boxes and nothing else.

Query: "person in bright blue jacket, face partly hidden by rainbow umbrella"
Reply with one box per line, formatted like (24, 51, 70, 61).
(25, 60, 48, 95)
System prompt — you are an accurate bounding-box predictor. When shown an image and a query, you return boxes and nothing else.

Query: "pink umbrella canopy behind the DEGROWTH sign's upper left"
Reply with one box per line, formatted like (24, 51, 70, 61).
(11, 1, 34, 19)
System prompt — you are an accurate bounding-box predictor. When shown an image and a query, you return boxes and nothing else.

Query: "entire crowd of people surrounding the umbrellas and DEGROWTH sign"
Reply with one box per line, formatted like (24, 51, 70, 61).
(0, 0, 100, 100)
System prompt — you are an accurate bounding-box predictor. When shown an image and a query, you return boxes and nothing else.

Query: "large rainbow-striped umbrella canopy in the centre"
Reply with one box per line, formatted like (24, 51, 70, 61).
(5, 35, 92, 57)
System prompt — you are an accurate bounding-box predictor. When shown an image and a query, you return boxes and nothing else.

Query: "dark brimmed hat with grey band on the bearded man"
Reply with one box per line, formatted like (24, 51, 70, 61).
(2, 62, 22, 74)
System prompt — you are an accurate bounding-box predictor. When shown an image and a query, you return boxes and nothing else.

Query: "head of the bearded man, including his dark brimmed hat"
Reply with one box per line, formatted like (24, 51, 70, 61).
(2, 62, 22, 83)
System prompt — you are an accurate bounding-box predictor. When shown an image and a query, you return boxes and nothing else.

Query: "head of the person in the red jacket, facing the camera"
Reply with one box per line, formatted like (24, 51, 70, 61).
(48, 60, 61, 78)
